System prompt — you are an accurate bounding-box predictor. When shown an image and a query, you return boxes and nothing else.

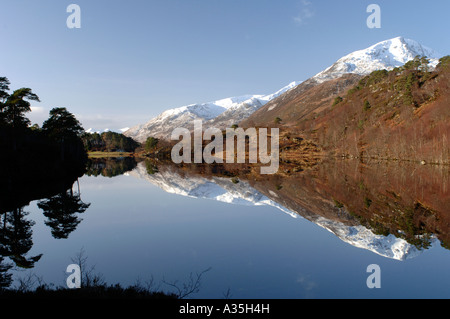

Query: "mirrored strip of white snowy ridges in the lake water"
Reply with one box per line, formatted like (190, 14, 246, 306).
(125, 162, 436, 260)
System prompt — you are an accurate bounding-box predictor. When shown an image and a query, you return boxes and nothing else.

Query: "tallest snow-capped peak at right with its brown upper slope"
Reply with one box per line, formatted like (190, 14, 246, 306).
(239, 37, 440, 127)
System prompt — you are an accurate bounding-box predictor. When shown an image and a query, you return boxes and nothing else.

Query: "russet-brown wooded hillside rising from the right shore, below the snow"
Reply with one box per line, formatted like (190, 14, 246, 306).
(240, 57, 450, 164)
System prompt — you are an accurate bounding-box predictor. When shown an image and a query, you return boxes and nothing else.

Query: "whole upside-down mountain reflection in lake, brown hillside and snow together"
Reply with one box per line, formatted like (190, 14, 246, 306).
(128, 161, 450, 260)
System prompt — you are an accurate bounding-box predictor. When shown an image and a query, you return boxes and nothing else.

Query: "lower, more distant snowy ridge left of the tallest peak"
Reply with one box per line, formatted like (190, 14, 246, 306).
(124, 82, 300, 142)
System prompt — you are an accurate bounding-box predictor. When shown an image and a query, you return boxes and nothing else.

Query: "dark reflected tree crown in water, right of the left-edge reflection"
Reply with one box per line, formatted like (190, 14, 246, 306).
(38, 182, 91, 239)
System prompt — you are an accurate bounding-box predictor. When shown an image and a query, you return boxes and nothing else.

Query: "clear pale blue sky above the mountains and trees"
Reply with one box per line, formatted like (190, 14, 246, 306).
(0, 0, 450, 130)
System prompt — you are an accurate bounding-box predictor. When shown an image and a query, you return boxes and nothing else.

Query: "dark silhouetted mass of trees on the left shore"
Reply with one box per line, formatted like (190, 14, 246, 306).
(0, 77, 87, 212)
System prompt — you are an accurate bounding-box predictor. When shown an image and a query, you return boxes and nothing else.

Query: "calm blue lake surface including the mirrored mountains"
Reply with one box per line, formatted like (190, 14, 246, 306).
(5, 158, 450, 299)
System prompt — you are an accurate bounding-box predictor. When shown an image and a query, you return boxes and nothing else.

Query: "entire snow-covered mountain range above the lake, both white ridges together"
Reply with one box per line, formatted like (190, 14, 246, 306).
(124, 37, 440, 142)
